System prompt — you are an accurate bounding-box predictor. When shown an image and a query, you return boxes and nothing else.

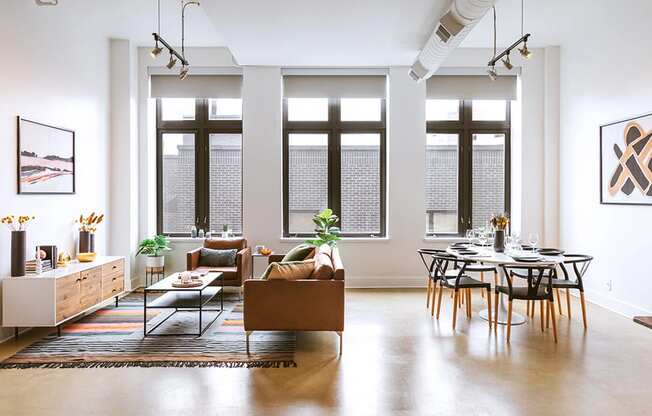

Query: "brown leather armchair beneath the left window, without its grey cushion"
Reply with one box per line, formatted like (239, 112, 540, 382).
(186, 237, 253, 287)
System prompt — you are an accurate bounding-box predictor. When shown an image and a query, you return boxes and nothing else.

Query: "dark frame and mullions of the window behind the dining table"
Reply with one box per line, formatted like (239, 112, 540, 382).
(426, 100, 512, 237)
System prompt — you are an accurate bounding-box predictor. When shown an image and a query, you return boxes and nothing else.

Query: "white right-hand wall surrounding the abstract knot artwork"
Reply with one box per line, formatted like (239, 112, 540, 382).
(560, 0, 652, 316)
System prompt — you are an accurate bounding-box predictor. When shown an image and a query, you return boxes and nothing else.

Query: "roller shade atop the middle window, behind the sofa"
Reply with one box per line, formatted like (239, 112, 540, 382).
(283, 75, 386, 98)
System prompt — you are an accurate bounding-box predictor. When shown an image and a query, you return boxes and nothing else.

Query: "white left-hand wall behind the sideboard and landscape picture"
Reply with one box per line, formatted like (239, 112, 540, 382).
(0, 2, 111, 339)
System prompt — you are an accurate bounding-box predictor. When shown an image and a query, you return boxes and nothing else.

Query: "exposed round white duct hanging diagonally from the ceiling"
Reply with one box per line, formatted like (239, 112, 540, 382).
(410, 0, 497, 81)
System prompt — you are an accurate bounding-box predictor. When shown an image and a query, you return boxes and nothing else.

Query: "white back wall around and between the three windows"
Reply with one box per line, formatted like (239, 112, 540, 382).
(139, 48, 545, 287)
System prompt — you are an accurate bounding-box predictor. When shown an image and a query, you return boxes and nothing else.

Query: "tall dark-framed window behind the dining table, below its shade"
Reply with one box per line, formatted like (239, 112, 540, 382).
(425, 99, 510, 236)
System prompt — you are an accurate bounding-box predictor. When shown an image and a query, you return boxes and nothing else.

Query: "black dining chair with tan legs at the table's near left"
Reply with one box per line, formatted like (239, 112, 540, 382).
(431, 252, 492, 331)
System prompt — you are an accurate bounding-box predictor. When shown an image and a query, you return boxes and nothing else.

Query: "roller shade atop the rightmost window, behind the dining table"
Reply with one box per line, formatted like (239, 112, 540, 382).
(426, 75, 516, 100)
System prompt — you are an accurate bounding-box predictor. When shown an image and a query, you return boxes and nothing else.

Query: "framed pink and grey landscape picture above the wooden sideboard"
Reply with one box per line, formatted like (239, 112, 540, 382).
(17, 117, 75, 194)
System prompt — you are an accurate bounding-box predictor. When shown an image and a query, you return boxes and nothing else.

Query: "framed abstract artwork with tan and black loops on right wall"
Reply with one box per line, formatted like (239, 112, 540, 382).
(600, 114, 652, 205)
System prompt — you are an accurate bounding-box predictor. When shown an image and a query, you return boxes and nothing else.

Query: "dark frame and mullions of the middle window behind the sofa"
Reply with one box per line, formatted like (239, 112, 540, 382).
(283, 97, 387, 238)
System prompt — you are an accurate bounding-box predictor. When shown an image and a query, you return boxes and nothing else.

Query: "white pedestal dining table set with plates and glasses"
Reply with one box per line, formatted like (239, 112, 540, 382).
(446, 245, 564, 325)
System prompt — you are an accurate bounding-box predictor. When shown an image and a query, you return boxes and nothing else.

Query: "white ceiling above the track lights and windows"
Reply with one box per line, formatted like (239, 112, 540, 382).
(25, 0, 570, 66)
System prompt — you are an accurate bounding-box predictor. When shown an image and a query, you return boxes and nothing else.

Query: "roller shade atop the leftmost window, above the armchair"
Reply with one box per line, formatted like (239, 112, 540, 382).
(150, 75, 242, 98)
